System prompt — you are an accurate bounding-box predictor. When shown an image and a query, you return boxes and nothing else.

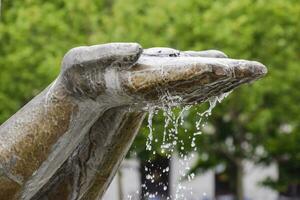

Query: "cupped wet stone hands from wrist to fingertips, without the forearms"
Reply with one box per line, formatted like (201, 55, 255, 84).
(57, 43, 267, 107)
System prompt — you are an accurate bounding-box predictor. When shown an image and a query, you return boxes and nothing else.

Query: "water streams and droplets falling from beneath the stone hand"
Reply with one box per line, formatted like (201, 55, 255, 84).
(136, 92, 230, 200)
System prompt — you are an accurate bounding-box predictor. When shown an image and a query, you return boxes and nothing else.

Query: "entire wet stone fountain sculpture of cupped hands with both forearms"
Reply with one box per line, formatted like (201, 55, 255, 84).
(0, 43, 267, 200)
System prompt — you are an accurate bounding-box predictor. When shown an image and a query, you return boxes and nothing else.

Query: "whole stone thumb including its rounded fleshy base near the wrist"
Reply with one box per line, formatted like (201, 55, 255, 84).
(60, 43, 142, 99)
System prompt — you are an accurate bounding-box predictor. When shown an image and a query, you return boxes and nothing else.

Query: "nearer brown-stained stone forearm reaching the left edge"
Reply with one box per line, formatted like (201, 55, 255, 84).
(0, 81, 83, 200)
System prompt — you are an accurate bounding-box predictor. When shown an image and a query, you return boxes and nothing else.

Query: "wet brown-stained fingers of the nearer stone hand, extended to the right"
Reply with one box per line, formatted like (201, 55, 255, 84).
(122, 56, 267, 103)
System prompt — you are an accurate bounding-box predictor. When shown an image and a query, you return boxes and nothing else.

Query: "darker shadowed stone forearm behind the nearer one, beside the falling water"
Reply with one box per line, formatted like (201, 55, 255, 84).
(32, 107, 145, 200)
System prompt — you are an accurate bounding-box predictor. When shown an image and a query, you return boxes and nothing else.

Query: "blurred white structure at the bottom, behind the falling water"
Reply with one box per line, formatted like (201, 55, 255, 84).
(103, 156, 278, 200)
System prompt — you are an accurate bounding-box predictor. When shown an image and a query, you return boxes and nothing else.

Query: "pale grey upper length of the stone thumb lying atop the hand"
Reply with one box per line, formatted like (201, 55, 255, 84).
(62, 43, 143, 70)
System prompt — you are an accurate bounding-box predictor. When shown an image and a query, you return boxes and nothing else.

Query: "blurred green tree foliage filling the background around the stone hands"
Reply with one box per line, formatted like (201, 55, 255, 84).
(0, 0, 300, 196)
